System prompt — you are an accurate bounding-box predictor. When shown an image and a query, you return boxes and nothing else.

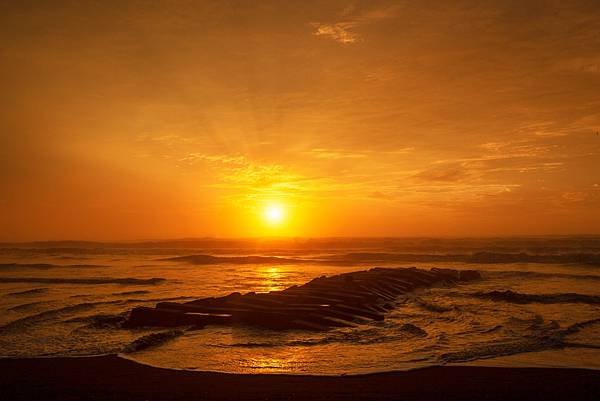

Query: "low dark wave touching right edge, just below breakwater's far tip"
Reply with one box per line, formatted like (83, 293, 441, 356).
(470, 290, 600, 305)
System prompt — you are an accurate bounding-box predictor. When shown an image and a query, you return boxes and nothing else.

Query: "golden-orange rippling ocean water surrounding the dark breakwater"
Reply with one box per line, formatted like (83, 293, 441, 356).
(0, 236, 600, 375)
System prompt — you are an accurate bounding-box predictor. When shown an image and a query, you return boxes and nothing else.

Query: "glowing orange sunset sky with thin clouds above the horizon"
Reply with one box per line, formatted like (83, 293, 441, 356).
(0, 0, 600, 241)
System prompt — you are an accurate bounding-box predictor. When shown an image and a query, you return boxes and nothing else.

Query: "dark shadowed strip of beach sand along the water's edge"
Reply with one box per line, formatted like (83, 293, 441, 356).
(0, 356, 600, 401)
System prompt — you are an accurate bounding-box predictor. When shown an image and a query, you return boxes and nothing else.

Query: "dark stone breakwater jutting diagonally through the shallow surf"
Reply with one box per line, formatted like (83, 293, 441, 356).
(125, 268, 481, 331)
